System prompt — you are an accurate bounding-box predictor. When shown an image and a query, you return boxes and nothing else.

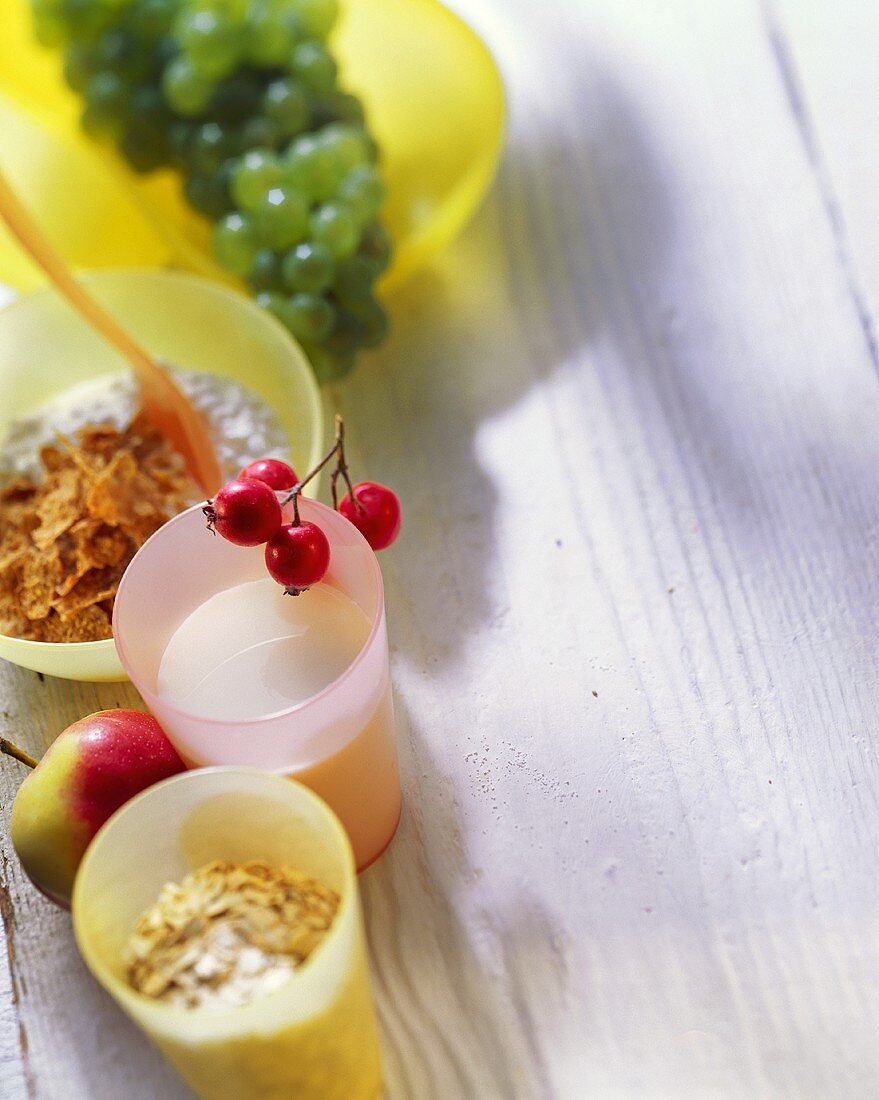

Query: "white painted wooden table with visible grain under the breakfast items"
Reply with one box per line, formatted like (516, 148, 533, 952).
(0, 0, 879, 1100)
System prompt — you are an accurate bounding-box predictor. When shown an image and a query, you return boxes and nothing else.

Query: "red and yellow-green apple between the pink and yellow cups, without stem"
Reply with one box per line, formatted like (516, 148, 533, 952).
(10, 711, 186, 906)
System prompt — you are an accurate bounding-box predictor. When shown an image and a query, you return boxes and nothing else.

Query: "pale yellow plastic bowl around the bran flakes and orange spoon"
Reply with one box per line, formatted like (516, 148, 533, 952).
(0, 271, 323, 681)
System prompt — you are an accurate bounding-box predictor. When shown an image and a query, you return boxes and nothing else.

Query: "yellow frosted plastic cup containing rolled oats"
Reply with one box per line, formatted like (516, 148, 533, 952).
(73, 768, 381, 1100)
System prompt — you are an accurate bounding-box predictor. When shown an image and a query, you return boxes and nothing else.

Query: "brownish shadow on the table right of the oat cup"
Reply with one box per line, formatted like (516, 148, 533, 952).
(361, 704, 565, 1100)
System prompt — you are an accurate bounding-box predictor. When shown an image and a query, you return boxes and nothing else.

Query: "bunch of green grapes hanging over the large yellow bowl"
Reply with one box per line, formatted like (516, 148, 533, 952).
(32, 0, 391, 381)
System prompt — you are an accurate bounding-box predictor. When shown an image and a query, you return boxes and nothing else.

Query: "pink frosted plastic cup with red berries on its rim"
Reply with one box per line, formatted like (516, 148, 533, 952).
(113, 501, 400, 870)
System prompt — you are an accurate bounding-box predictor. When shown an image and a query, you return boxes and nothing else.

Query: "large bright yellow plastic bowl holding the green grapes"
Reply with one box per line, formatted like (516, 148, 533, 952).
(0, 0, 504, 293)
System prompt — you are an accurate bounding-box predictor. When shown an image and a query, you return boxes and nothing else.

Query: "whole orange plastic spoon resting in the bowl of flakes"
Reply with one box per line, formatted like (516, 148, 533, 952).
(0, 172, 222, 496)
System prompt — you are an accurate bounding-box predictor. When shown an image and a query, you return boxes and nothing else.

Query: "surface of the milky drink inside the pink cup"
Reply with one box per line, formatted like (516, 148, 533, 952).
(157, 578, 370, 721)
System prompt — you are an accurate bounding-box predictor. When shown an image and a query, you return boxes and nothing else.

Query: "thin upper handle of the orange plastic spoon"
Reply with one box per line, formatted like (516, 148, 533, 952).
(0, 171, 161, 374)
